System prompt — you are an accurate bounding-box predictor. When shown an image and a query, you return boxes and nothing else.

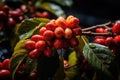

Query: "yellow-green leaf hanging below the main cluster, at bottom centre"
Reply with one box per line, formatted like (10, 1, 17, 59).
(64, 51, 78, 80)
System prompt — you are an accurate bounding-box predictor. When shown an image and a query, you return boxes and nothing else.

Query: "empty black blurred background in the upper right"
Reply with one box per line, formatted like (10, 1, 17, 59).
(65, 0, 120, 27)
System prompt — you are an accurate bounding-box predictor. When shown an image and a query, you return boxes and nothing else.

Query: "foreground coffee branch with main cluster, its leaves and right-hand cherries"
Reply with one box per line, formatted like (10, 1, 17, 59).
(6, 15, 120, 80)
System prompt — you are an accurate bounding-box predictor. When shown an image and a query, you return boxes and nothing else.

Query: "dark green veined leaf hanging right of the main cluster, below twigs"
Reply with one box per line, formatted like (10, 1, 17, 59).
(83, 43, 114, 78)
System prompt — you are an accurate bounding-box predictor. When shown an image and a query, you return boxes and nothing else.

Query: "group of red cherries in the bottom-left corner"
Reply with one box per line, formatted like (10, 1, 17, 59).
(0, 58, 10, 79)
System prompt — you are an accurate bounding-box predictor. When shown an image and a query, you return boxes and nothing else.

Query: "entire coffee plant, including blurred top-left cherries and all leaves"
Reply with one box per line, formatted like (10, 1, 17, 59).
(0, 0, 120, 80)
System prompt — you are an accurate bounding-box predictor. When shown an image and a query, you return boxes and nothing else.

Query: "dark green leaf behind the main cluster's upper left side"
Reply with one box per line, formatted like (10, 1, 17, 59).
(16, 18, 49, 35)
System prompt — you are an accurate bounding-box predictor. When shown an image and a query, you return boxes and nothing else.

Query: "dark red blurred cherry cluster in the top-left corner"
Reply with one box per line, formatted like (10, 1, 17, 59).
(0, 5, 25, 28)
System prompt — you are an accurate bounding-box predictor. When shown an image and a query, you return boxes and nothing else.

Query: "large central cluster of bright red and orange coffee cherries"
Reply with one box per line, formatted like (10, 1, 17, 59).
(24, 15, 82, 59)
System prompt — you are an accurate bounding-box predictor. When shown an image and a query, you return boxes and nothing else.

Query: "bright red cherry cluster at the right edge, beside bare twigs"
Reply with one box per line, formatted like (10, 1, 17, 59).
(94, 21, 120, 54)
